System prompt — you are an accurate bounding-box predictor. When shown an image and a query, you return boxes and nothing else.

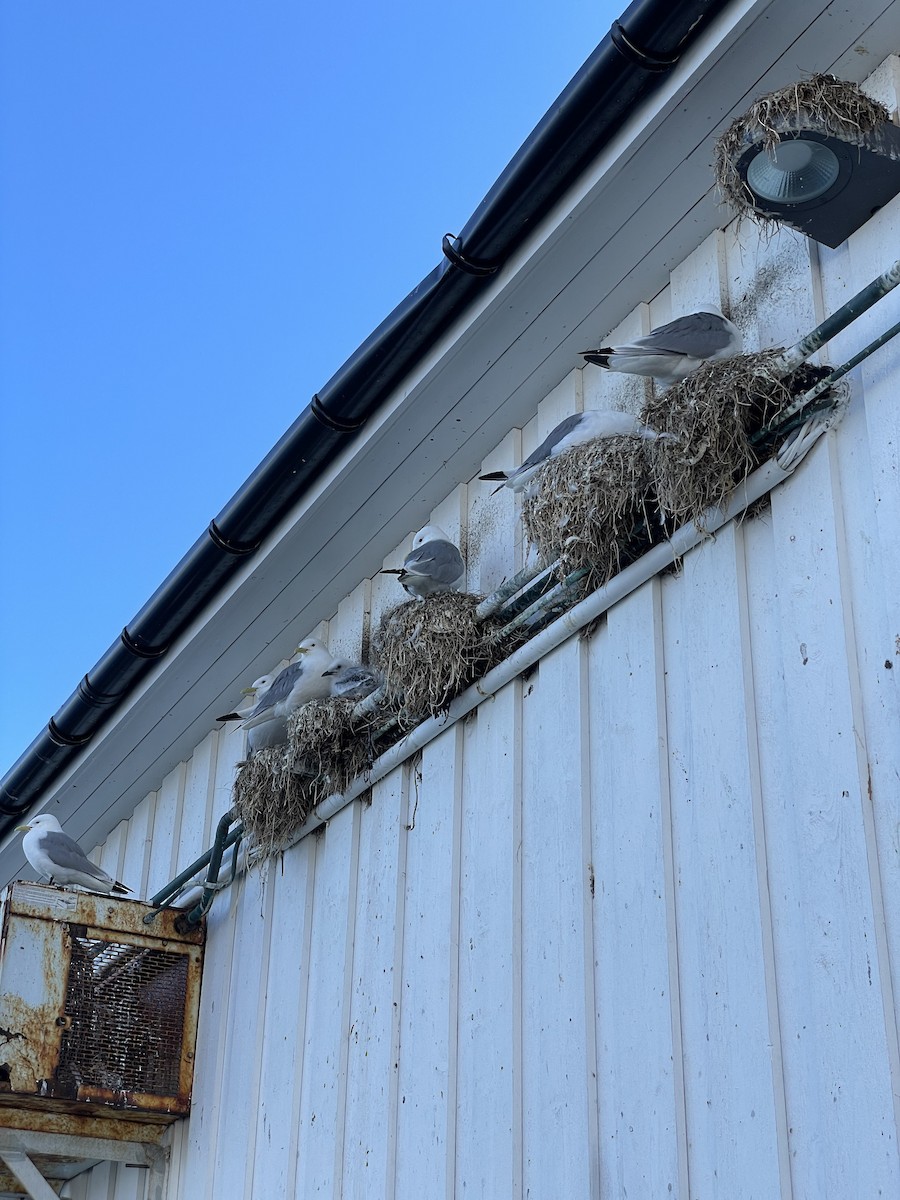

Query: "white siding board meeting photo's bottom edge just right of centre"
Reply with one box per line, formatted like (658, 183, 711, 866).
(456, 683, 522, 1200)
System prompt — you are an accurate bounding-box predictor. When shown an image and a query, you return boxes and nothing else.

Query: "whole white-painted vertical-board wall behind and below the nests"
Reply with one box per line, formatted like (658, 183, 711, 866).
(60, 60, 900, 1200)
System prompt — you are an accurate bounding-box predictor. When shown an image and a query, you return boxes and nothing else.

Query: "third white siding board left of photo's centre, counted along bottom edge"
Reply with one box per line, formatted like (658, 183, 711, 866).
(296, 800, 364, 1200)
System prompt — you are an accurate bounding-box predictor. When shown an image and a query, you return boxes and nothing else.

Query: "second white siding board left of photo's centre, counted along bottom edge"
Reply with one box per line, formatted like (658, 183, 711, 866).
(342, 764, 415, 1200)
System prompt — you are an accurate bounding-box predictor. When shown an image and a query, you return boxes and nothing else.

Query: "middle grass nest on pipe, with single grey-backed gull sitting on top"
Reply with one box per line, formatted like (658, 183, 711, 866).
(372, 592, 505, 726)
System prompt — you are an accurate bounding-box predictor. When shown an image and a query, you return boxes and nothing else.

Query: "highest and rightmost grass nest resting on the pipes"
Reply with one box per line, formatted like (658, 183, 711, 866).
(643, 350, 830, 528)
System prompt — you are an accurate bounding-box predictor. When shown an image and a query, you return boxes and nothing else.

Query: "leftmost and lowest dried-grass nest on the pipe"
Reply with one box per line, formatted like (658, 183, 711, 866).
(233, 746, 314, 857)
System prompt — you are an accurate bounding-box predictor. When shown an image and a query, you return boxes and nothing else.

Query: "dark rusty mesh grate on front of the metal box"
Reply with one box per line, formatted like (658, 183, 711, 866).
(58, 936, 188, 1096)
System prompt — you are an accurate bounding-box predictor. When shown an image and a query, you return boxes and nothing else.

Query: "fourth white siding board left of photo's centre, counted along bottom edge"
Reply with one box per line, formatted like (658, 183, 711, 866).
(252, 836, 320, 1200)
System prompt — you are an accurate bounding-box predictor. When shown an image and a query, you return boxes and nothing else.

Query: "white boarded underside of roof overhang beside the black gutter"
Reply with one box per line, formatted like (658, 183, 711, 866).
(0, 0, 900, 878)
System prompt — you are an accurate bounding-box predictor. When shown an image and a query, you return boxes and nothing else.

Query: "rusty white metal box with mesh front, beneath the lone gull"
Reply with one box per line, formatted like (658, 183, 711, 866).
(0, 882, 204, 1126)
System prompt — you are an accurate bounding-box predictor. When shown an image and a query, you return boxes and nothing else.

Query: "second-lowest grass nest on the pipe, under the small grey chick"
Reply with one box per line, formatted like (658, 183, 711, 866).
(287, 697, 384, 811)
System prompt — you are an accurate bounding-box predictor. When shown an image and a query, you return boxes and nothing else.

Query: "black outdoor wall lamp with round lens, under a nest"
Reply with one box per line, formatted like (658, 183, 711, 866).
(734, 114, 900, 247)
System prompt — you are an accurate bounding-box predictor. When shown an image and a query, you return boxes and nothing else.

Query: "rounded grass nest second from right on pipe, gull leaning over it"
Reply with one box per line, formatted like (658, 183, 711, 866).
(522, 437, 652, 590)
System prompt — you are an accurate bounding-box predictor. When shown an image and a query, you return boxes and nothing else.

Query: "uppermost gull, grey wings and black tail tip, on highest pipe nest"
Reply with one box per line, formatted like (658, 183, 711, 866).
(582, 305, 742, 388)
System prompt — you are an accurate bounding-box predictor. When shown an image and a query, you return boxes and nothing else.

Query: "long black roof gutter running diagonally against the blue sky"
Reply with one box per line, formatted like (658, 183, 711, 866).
(0, 0, 730, 836)
